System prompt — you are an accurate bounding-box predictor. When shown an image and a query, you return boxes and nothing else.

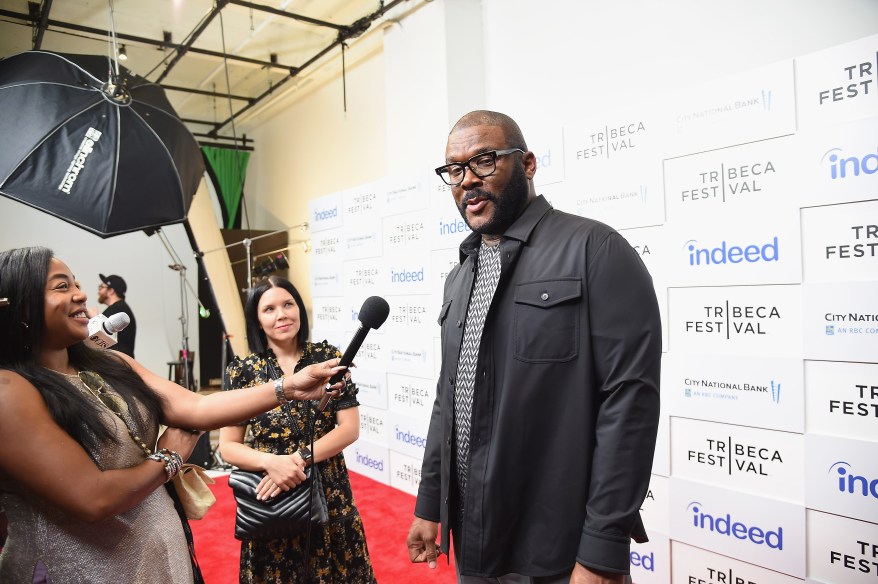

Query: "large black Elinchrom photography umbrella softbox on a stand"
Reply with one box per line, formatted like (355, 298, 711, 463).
(0, 51, 204, 237)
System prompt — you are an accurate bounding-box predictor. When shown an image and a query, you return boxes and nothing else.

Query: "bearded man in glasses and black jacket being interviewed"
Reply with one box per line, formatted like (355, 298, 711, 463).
(407, 111, 661, 584)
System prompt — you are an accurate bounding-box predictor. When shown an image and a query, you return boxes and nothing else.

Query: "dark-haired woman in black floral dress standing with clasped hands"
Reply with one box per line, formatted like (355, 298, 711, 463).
(220, 276, 375, 584)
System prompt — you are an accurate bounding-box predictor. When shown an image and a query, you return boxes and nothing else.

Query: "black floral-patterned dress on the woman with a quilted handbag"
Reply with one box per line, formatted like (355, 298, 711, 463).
(226, 341, 376, 584)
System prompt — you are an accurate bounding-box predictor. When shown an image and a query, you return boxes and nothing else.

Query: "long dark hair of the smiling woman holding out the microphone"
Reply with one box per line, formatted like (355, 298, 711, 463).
(0, 247, 162, 454)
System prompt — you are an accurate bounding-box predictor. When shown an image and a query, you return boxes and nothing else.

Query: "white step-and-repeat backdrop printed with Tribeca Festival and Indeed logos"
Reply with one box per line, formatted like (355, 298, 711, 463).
(310, 35, 878, 584)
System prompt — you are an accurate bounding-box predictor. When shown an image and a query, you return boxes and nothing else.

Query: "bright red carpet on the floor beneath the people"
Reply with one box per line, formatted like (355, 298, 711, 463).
(191, 472, 457, 584)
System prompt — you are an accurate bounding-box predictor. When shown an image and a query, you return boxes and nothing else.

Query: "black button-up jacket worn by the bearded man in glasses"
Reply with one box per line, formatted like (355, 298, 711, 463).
(415, 197, 661, 577)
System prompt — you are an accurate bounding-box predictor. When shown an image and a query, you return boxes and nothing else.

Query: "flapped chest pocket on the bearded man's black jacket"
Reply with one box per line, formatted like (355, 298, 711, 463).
(512, 279, 582, 363)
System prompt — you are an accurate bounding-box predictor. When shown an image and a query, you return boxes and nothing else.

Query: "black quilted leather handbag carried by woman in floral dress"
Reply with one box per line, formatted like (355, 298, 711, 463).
(229, 465, 329, 541)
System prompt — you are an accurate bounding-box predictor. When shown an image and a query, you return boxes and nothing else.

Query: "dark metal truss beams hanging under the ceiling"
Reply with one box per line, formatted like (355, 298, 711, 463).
(0, 0, 408, 149)
